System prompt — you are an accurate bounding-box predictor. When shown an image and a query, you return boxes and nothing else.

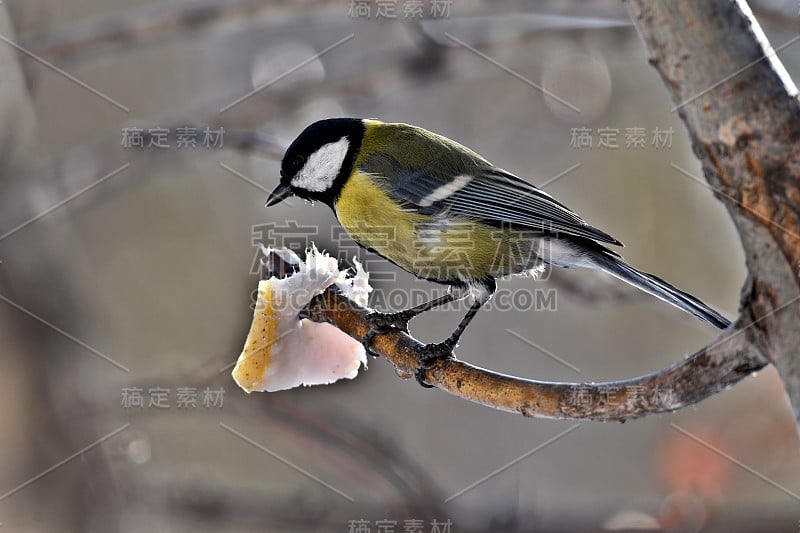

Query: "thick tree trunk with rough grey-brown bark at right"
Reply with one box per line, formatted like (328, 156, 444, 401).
(625, 0, 800, 420)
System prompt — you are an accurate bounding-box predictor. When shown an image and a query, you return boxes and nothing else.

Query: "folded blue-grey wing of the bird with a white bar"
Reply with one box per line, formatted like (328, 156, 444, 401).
(384, 166, 622, 246)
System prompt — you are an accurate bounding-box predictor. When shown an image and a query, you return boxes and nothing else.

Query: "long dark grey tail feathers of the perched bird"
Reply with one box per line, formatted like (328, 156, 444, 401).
(592, 251, 731, 329)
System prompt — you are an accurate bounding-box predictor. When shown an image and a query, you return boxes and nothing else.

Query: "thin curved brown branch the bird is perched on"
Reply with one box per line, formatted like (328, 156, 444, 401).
(302, 282, 767, 421)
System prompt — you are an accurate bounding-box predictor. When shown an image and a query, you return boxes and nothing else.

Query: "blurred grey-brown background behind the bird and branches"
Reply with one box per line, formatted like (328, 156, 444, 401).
(0, 0, 800, 533)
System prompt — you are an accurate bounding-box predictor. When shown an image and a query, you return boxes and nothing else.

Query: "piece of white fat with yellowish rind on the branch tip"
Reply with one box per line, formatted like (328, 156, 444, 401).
(233, 247, 372, 393)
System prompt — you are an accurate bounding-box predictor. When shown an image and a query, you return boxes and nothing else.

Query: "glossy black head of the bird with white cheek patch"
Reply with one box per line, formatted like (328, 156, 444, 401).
(267, 118, 364, 206)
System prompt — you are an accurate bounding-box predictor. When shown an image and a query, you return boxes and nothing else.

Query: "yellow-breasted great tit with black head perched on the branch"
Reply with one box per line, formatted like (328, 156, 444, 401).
(266, 118, 730, 384)
